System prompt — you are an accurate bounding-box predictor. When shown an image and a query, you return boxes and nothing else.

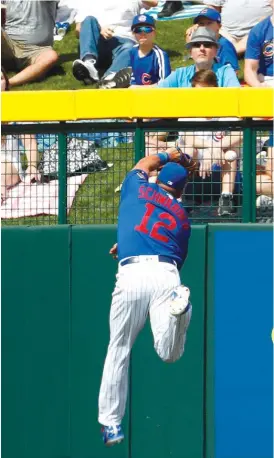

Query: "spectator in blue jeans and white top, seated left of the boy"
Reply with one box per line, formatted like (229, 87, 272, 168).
(72, 0, 158, 88)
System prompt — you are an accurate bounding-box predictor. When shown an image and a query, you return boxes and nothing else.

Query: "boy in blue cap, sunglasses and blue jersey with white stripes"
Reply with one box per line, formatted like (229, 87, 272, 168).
(130, 14, 171, 85)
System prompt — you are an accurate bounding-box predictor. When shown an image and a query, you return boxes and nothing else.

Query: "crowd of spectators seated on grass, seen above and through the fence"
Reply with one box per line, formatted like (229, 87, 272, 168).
(1, 0, 274, 220)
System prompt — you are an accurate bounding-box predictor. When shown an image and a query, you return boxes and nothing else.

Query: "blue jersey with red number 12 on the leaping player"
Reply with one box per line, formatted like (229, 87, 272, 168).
(117, 169, 191, 269)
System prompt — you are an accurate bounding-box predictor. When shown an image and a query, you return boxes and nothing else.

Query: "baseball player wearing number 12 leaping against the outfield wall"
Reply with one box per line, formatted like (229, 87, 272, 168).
(99, 148, 192, 446)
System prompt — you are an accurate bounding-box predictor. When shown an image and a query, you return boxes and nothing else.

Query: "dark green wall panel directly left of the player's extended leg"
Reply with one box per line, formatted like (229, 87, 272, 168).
(71, 225, 129, 458)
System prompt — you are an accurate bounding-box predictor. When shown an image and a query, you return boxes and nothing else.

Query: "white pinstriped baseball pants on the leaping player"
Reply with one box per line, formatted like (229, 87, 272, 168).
(98, 256, 191, 426)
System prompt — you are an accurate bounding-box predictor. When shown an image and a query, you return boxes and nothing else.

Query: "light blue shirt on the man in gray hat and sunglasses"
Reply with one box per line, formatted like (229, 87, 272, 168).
(158, 63, 240, 87)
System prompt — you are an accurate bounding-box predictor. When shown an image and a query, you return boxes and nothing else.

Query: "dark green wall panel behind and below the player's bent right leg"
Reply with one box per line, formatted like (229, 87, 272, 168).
(131, 226, 206, 458)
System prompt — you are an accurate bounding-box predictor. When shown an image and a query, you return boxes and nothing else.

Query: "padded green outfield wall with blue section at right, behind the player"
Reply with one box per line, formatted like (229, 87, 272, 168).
(2, 224, 273, 458)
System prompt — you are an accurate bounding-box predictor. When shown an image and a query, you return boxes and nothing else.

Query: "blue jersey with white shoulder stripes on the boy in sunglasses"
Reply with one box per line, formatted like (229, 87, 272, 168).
(130, 45, 171, 86)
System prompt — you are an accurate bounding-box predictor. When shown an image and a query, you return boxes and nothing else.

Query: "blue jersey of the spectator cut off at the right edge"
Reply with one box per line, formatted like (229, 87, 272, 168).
(245, 17, 274, 76)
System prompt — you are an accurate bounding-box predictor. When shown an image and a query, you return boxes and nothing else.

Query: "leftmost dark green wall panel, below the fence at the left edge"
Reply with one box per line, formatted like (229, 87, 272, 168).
(2, 227, 70, 458)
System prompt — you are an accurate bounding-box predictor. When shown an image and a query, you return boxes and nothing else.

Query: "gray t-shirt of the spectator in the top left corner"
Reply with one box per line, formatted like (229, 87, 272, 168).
(5, 0, 57, 46)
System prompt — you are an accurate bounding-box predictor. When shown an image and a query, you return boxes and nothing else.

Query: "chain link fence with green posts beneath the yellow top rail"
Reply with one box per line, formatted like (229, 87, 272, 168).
(1, 118, 274, 225)
